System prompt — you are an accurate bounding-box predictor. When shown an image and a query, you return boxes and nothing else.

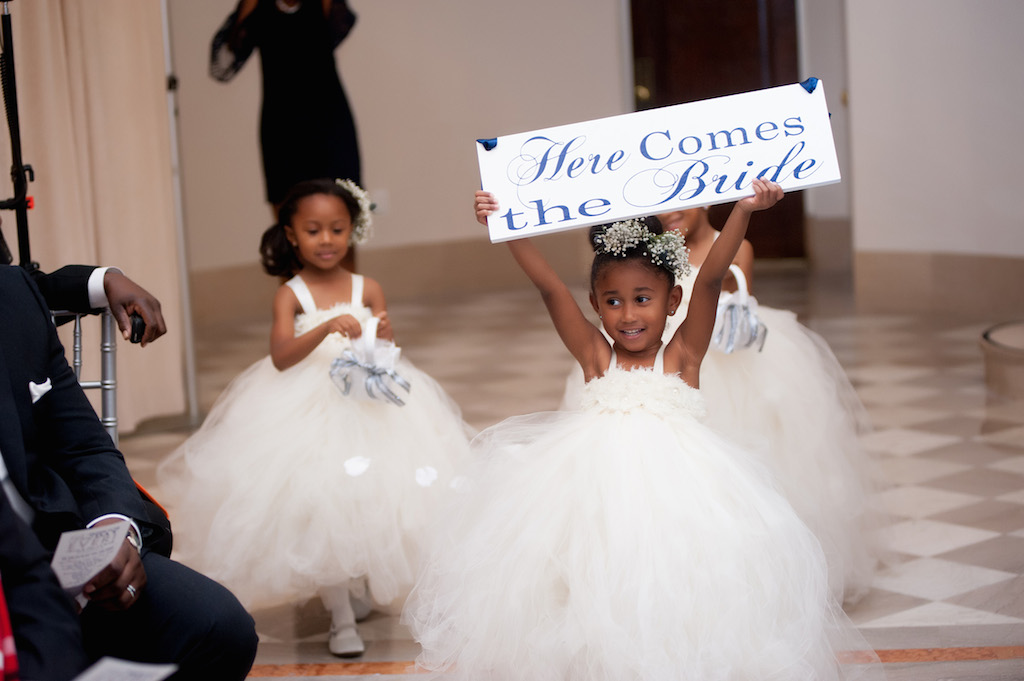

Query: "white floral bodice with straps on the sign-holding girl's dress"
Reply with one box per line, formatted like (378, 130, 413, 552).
(581, 345, 708, 421)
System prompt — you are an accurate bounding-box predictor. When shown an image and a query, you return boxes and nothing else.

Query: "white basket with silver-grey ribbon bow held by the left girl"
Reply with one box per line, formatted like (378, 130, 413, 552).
(331, 317, 411, 407)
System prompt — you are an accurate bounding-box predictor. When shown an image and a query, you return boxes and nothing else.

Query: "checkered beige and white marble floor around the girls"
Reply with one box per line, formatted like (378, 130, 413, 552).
(122, 267, 1024, 681)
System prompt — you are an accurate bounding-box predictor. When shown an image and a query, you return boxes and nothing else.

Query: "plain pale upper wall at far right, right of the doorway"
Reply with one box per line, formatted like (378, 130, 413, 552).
(846, 0, 1024, 257)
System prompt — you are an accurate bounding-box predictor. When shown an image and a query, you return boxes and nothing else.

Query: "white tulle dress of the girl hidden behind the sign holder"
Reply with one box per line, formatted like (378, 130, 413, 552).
(562, 266, 884, 602)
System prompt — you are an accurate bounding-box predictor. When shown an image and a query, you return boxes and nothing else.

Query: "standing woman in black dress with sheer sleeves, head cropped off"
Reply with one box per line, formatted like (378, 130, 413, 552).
(210, 0, 361, 211)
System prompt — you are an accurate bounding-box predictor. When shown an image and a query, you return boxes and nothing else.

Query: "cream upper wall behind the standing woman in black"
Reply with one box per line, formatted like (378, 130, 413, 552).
(169, 0, 632, 271)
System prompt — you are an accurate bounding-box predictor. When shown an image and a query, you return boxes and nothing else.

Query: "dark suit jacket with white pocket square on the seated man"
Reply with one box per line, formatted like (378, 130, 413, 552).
(0, 266, 167, 550)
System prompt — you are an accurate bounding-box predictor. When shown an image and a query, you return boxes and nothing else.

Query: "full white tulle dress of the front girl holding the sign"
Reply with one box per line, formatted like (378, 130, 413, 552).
(402, 346, 878, 681)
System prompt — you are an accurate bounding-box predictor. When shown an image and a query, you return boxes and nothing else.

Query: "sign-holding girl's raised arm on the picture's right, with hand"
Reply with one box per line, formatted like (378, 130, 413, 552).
(674, 179, 782, 366)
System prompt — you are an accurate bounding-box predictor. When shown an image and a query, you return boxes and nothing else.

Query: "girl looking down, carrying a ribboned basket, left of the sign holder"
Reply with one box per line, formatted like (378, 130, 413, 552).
(158, 179, 469, 656)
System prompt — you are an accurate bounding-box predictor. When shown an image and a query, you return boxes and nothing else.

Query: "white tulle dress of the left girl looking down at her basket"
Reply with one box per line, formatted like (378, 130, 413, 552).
(158, 275, 471, 609)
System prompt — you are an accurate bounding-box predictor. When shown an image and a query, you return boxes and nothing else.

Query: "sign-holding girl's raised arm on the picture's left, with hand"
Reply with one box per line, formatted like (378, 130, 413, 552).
(474, 190, 607, 372)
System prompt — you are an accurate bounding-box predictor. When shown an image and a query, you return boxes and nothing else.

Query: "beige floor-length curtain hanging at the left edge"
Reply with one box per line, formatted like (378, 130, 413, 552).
(0, 0, 185, 432)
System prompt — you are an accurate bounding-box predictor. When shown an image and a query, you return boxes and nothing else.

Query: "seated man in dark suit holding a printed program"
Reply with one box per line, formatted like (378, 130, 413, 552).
(0, 266, 256, 681)
